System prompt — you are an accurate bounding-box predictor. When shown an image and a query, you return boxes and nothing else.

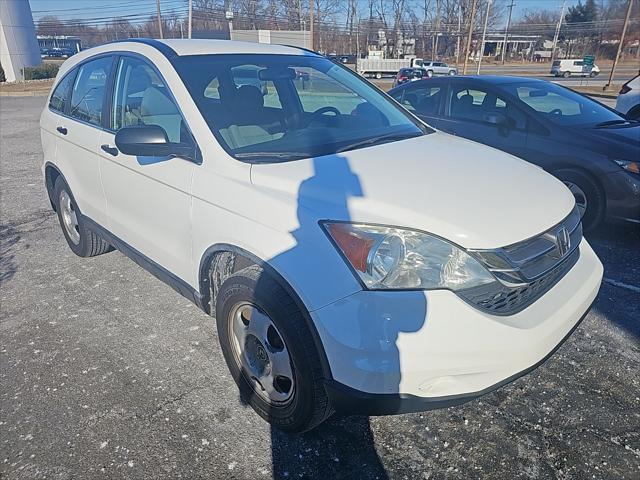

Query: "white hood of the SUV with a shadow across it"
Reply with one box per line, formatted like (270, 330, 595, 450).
(251, 132, 574, 248)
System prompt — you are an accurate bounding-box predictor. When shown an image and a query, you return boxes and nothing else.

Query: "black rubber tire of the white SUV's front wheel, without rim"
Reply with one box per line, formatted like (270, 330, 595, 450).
(215, 265, 333, 432)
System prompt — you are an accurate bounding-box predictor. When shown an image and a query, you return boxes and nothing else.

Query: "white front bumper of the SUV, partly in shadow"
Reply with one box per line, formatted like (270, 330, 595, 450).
(311, 240, 603, 415)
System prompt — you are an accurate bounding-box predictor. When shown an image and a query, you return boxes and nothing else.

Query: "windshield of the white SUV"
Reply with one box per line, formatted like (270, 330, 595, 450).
(175, 55, 431, 162)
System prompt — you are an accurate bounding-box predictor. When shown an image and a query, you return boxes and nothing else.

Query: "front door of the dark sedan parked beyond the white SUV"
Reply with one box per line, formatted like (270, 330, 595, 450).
(436, 82, 527, 157)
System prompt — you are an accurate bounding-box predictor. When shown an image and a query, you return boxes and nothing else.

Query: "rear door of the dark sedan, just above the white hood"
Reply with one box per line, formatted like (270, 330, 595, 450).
(391, 80, 445, 128)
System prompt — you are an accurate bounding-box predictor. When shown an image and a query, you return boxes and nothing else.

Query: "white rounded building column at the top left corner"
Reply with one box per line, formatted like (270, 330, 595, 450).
(0, 0, 42, 82)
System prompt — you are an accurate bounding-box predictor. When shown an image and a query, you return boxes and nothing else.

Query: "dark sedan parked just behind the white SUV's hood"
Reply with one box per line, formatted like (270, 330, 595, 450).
(389, 76, 640, 229)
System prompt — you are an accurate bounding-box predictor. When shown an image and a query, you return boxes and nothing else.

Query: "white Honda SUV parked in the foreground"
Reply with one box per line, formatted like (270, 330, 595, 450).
(41, 40, 602, 431)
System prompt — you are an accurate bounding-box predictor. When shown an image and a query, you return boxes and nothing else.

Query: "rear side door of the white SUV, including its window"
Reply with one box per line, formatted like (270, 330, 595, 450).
(55, 55, 114, 224)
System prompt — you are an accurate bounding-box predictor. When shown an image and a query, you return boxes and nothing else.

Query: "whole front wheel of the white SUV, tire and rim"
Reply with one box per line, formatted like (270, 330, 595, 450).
(216, 265, 332, 432)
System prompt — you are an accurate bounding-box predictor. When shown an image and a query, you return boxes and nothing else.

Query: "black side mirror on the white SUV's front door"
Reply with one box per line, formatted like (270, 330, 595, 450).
(115, 125, 196, 161)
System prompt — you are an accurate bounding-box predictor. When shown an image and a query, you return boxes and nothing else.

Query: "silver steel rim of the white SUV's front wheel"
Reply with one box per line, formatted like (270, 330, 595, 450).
(227, 302, 295, 405)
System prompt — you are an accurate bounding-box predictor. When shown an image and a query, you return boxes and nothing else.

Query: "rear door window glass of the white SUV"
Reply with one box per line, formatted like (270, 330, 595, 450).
(69, 56, 113, 125)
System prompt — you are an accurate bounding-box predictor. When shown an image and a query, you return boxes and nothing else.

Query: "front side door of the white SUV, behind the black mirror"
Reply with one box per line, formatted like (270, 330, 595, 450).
(100, 56, 197, 279)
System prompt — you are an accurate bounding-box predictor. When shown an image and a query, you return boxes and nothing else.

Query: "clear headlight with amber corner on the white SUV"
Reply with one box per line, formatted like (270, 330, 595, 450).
(322, 222, 496, 291)
